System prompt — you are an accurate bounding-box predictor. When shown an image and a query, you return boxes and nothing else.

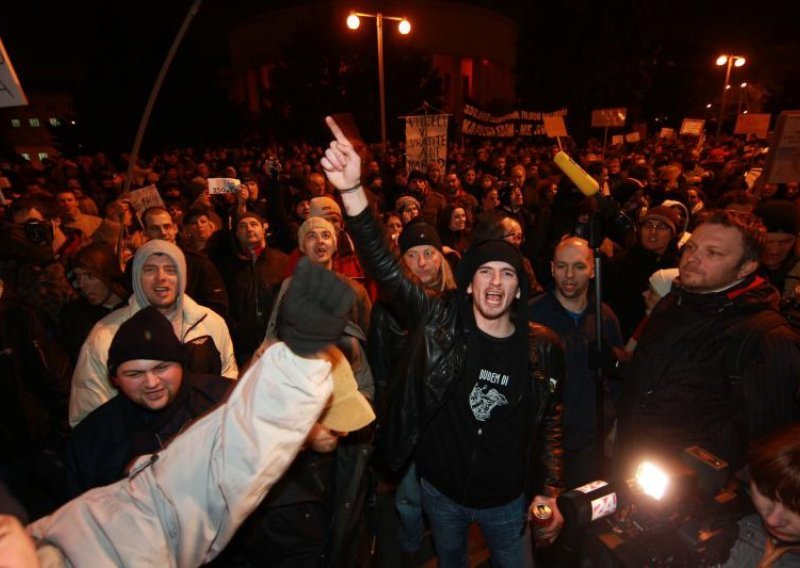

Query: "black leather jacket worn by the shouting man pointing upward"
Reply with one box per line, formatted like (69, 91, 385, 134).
(347, 209, 565, 495)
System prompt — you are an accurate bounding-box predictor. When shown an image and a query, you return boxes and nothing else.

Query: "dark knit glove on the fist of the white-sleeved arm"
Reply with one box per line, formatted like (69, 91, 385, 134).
(280, 257, 355, 355)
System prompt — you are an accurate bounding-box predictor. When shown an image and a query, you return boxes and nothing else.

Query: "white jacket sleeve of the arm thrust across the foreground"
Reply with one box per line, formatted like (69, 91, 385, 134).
(29, 343, 331, 567)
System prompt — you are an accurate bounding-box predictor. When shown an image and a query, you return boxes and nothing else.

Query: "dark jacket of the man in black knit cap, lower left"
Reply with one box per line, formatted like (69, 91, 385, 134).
(67, 370, 236, 496)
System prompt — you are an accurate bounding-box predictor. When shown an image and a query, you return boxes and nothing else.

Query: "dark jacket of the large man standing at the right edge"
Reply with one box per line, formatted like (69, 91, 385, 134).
(619, 276, 800, 470)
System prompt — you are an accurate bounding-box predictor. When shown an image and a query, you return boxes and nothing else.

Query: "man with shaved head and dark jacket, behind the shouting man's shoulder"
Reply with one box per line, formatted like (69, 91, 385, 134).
(530, 237, 622, 487)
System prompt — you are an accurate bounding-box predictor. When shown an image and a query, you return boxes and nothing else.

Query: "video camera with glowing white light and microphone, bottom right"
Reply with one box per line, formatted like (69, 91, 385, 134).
(558, 446, 751, 568)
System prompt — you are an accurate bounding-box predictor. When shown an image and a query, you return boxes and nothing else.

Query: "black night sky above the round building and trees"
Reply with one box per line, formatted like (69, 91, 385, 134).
(0, 0, 800, 91)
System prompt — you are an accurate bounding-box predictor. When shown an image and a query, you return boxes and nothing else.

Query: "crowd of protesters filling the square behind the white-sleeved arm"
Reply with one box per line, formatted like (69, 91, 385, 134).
(0, 118, 800, 566)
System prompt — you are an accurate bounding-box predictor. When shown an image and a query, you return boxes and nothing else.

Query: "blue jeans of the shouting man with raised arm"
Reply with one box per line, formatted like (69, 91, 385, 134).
(421, 479, 527, 568)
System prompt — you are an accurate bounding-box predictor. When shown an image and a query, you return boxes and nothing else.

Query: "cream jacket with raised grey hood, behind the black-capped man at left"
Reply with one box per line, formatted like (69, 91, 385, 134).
(69, 240, 239, 428)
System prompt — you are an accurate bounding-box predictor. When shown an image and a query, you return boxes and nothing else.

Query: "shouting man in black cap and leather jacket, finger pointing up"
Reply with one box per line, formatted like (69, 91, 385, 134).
(322, 118, 564, 567)
